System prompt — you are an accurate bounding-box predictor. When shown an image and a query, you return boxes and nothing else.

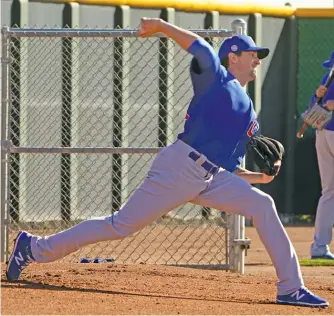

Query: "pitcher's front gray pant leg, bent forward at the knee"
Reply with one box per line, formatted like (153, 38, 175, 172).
(193, 170, 304, 295)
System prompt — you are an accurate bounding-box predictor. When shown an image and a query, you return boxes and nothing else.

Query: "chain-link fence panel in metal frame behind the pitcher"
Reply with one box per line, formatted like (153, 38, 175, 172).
(1, 21, 249, 270)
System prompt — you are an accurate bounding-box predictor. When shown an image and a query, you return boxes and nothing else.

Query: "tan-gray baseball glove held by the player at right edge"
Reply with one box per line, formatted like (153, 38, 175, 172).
(301, 103, 332, 130)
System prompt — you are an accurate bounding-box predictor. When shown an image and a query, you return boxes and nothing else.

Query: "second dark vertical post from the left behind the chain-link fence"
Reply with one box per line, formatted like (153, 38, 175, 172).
(60, 3, 79, 225)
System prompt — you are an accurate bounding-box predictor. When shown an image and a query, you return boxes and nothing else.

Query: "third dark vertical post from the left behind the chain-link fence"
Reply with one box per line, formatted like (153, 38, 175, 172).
(111, 6, 130, 212)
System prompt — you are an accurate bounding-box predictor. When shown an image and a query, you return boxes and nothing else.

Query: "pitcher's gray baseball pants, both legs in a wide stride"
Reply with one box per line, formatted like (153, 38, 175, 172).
(31, 140, 303, 295)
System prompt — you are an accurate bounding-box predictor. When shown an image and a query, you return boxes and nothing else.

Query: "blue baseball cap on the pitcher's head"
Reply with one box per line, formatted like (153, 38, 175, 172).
(218, 35, 269, 60)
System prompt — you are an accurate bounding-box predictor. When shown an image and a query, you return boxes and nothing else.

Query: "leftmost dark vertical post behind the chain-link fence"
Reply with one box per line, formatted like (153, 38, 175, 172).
(8, 0, 28, 223)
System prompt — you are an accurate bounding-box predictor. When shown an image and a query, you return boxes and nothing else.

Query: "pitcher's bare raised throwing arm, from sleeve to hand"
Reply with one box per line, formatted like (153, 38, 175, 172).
(139, 18, 199, 51)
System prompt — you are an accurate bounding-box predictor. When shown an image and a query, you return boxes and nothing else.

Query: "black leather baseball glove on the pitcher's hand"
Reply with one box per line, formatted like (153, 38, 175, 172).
(247, 135, 284, 176)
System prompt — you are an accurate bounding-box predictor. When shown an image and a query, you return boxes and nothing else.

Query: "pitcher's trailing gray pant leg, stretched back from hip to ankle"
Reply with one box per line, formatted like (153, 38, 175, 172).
(31, 143, 208, 262)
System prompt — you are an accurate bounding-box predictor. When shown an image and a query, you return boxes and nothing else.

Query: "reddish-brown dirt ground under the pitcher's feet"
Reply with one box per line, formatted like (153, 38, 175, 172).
(1, 227, 334, 315)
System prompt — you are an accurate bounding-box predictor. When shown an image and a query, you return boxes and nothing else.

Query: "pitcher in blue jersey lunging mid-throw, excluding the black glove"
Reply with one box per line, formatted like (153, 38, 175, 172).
(7, 18, 328, 307)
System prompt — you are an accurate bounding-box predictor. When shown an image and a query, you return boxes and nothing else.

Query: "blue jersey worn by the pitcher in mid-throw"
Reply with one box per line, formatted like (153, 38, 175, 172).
(178, 39, 259, 172)
